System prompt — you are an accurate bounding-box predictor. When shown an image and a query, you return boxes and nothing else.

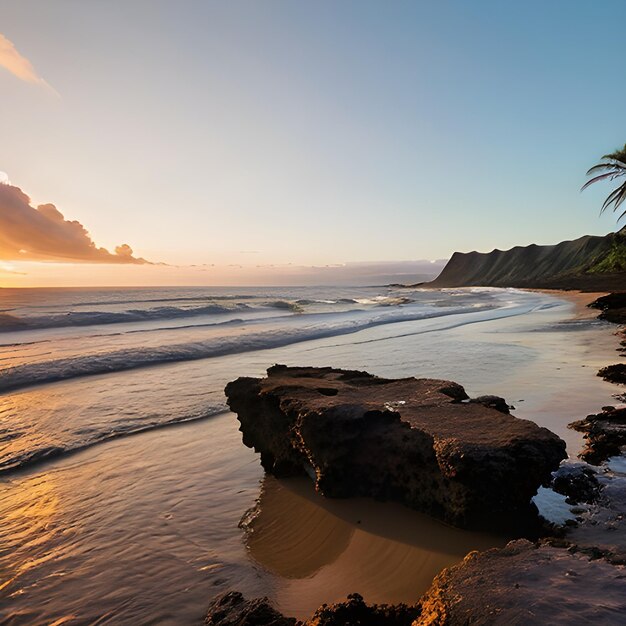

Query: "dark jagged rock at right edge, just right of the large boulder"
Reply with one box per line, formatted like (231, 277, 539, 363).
(569, 406, 626, 465)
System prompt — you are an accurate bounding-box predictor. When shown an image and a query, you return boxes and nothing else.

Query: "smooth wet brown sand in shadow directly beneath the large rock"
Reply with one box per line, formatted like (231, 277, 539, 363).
(246, 476, 507, 617)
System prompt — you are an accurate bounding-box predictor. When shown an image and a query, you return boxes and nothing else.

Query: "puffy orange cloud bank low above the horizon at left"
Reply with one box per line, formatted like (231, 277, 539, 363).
(0, 184, 150, 264)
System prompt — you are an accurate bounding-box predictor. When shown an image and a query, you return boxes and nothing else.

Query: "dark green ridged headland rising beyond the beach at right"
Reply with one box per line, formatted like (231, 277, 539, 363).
(428, 228, 626, 291)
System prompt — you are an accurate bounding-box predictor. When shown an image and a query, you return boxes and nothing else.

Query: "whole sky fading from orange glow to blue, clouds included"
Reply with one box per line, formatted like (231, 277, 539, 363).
(0, 0, 626, 286)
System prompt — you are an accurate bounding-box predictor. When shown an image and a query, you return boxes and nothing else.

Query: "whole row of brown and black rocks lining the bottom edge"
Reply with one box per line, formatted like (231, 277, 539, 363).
(205, 539, 626, 626)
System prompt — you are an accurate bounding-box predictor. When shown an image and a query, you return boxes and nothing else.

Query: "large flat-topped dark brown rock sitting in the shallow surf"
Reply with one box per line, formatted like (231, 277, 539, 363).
(226, 365, 565, 533)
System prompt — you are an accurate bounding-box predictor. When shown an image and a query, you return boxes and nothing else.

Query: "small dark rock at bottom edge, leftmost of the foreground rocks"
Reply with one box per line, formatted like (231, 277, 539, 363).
(204, 591, 296, 626)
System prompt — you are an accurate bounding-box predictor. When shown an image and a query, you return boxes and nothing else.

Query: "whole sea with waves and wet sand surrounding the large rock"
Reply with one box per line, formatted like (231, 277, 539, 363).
(0, 287, 614, 624)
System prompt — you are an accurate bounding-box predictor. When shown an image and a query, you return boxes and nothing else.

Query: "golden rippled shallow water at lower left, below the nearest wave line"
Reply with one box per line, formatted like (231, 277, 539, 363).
(0, 414, 263, 626)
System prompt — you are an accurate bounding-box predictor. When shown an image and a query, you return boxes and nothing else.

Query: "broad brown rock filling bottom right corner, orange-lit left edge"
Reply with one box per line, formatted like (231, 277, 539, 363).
(414, 539, 626, 626)
